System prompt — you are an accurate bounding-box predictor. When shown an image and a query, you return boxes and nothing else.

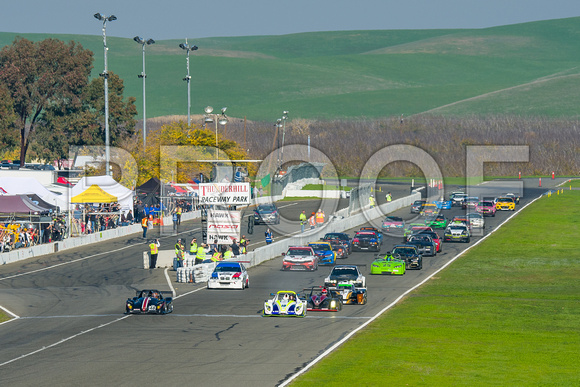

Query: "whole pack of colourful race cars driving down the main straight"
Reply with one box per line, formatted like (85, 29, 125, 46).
(125, 192, 520, 317)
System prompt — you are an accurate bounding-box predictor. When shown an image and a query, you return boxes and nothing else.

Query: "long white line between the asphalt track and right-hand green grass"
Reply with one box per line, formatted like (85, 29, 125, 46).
(279, 196, 542, 387)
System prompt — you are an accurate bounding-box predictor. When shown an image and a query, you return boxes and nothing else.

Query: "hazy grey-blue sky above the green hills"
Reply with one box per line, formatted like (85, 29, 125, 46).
(0, 0, 580, 40)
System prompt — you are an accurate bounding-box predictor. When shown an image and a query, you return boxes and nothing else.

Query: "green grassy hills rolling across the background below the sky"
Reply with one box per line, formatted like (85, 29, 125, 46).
(0, 18, 580, 121)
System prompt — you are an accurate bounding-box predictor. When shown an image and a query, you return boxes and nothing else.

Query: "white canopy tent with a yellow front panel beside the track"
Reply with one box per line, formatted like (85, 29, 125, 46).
(70, 176, 135, 212)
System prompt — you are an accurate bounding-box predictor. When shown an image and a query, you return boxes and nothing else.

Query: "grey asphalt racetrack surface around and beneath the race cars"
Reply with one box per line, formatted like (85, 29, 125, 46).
(0, 181, 560, 386)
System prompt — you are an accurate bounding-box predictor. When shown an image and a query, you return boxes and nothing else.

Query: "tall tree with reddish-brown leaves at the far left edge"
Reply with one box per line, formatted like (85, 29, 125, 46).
(0, 37, 93, 166)
